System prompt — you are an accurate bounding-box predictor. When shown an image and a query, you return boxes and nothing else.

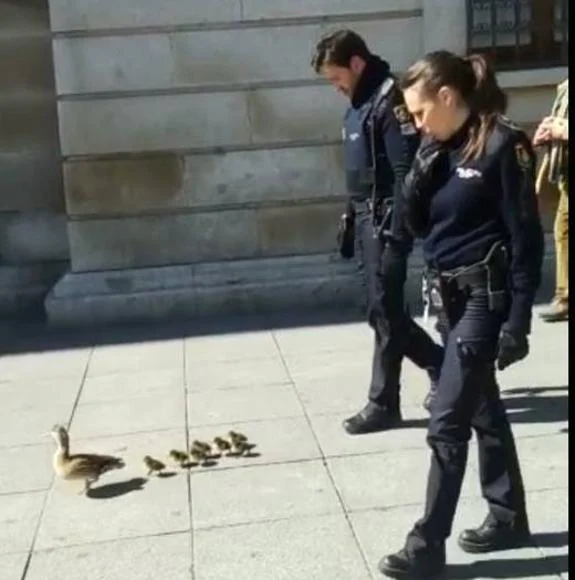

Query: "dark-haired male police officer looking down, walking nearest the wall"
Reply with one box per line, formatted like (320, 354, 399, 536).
(312, 30, 443, 434)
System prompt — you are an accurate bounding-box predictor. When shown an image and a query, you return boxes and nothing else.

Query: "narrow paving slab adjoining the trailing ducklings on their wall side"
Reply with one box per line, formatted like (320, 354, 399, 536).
(188, 385, 303, 426)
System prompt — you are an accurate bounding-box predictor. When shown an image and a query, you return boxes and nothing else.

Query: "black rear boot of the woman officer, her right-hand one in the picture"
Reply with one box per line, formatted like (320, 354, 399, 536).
(458, 515, 531, 554)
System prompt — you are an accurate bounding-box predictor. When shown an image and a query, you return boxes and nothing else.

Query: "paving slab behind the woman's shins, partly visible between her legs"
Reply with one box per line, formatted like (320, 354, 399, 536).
(327, 449, 479, 511)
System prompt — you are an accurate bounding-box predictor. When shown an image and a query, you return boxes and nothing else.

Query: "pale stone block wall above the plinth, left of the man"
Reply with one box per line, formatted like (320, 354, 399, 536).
(50, 0, 422, 272)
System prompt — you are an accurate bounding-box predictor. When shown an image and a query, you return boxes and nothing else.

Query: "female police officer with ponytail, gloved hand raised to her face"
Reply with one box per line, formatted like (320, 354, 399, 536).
(380, 51, 543, 578)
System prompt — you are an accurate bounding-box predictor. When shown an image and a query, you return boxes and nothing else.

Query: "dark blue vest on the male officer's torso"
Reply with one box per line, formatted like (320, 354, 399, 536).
(342, 77, 395, 200)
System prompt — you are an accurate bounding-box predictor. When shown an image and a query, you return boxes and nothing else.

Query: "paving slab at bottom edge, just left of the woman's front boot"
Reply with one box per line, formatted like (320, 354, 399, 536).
(194, 514, 370, 580)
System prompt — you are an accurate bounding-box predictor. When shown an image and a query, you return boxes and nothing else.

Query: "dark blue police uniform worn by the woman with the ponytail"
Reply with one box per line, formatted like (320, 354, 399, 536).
(387, 117, 543, 569)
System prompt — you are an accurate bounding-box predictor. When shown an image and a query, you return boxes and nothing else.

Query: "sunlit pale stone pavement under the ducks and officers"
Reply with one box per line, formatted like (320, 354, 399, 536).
(0, 306, 568, 580)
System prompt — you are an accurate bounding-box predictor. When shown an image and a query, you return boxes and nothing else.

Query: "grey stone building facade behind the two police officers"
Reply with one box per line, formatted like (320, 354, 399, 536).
(0, 0, 566, 324)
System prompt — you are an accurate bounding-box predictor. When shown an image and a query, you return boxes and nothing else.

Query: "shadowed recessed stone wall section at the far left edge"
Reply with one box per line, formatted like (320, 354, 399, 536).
(0, 0, 68, 316)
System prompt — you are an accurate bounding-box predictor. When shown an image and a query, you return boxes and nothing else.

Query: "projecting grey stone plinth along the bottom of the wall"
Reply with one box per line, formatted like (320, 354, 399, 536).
(45, 255, 362, 326)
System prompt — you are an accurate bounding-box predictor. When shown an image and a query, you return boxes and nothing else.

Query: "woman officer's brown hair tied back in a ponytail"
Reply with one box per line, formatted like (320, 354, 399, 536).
(400, 50, 507, 161)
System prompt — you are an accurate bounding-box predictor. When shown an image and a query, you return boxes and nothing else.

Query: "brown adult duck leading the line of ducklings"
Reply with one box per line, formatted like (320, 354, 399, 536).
(50, 425, 125, 493)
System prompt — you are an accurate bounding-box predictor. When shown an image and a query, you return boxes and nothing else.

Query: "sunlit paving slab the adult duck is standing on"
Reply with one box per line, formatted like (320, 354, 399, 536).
(36, 429, 190, 550)
